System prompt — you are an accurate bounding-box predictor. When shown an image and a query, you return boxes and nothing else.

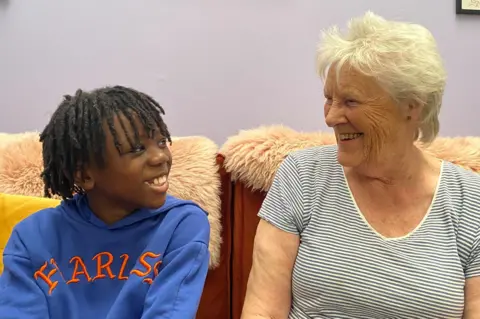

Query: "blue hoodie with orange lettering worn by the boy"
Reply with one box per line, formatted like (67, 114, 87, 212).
(0, 195, 210, 319)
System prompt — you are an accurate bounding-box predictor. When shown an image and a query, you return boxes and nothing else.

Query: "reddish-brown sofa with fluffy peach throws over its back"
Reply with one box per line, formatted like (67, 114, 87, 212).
(0, 125, 480, 319)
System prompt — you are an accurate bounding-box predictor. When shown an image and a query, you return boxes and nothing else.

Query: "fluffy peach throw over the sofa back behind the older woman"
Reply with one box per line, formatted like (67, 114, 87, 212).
(220, 125, 480, 192)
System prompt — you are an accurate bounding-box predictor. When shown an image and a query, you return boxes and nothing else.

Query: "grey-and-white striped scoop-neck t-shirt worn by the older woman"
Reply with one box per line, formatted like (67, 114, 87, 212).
(259, 146, 480, 319)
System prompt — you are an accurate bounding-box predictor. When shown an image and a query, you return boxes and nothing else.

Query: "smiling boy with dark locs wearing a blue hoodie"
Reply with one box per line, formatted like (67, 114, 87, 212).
(0, 86, 210, 319)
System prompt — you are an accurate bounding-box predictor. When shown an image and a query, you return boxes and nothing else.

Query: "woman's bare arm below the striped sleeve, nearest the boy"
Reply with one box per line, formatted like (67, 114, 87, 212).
(242, 220, 300, 319)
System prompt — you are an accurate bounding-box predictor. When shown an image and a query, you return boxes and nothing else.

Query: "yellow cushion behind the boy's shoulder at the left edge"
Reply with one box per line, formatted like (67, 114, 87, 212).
(0, 193, 60, 274)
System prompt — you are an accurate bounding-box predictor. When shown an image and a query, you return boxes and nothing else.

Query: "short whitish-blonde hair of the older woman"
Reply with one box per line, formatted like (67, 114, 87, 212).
(317, 11, 446, 143)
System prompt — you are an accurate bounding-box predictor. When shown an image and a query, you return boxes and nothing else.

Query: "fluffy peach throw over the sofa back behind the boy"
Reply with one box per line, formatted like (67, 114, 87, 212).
(0, 132, 222, 268)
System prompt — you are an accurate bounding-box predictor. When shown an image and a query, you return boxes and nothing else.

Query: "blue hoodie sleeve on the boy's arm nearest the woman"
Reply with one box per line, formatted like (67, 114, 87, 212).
(141, 208, 210, 319)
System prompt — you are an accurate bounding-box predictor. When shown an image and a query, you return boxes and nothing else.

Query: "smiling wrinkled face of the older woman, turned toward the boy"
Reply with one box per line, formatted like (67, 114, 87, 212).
(325, 65, 413, 167)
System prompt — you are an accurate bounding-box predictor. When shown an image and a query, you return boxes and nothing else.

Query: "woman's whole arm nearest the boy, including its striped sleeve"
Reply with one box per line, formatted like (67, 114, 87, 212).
(242, 154, 308, 319)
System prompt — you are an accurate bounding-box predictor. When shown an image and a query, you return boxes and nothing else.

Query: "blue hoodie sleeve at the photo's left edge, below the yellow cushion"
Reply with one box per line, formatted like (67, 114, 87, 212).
(0, 230, 49, 319)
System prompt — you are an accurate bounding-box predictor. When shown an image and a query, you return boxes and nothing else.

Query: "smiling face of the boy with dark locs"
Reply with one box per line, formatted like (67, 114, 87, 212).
(80, 115, 172, 222)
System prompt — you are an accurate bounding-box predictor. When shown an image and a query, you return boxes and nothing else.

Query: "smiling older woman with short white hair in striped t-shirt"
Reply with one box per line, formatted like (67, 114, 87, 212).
(242, 13, 480, 319)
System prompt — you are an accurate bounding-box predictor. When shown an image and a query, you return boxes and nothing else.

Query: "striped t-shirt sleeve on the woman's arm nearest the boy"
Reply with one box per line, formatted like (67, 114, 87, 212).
(258, 155, 304, 235)
